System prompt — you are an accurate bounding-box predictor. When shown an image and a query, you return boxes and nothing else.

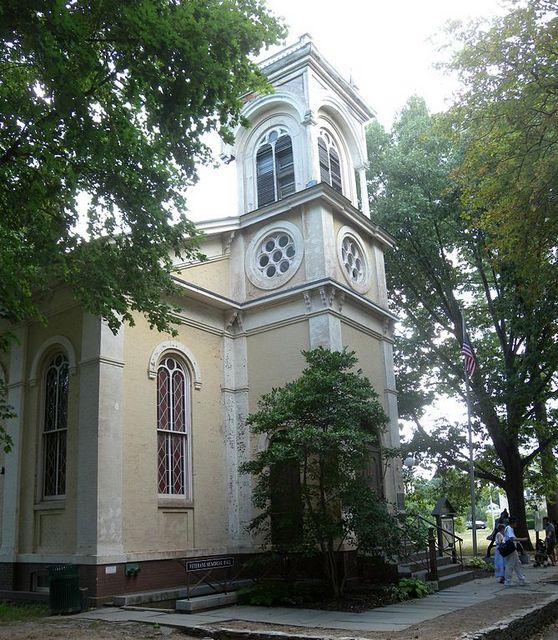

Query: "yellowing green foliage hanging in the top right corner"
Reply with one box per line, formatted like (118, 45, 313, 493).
(449, 0, 558, 282)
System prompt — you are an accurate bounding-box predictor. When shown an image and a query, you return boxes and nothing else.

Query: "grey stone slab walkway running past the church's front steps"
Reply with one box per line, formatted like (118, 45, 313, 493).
(77, 565, 558, 631)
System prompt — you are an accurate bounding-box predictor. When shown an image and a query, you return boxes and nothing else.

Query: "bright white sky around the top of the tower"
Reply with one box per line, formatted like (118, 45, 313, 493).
(188, 0, 503, 221)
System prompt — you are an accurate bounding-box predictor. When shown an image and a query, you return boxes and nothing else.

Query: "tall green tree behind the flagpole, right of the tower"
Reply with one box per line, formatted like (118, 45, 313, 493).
(368, 98, 558, 544)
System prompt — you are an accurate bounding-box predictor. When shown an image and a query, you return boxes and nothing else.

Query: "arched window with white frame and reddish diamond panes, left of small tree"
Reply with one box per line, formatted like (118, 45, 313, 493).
(157, 357, 190, 497)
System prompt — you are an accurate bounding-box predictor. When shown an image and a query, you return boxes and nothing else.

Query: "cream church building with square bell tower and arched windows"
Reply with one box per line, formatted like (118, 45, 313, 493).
(0, 36, 402, 601)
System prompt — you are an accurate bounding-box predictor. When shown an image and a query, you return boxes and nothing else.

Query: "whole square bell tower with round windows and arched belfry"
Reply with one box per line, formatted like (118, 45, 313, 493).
(224, 35, 403, 520)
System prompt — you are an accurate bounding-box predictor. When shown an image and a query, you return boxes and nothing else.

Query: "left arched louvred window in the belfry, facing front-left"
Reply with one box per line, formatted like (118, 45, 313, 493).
(256, 127, 295, 207)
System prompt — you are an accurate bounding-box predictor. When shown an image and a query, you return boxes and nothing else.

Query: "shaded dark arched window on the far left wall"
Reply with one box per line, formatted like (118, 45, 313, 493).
(43, 353, 70, 498)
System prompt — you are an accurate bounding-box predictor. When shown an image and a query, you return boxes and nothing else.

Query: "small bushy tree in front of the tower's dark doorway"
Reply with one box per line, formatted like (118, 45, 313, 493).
(243, 347, 395, 596)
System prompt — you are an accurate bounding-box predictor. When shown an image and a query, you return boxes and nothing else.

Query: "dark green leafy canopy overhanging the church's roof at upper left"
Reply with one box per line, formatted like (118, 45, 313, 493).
(0, 0, 282, 346)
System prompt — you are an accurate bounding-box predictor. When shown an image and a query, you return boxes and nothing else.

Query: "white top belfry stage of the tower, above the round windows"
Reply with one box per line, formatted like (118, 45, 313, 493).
(235, 34, 374, 216)
